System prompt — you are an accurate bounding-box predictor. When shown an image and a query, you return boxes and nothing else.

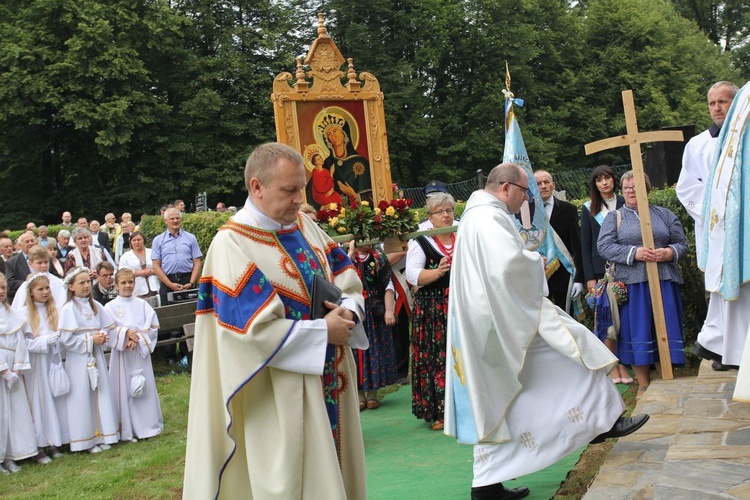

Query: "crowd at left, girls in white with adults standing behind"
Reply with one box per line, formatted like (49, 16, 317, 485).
(0, 200, 210, 474)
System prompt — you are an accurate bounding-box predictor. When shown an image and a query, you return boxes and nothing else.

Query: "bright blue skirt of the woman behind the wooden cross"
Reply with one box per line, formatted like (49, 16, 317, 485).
(617, 281, 685, 366)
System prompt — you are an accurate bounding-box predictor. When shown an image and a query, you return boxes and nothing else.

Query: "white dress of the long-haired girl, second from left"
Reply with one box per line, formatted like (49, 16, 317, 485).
(21, 302, 70, 448)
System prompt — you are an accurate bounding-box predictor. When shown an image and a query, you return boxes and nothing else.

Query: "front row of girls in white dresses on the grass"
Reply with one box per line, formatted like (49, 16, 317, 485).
(0, 264, 163, 474)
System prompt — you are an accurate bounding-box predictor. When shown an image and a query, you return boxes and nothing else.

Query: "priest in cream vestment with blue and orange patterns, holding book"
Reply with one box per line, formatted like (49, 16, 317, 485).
(183, 143, 368, 500)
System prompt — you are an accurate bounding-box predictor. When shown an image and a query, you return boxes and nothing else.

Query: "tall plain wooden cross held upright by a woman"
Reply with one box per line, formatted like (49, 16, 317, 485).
(585, 90, 683, 380)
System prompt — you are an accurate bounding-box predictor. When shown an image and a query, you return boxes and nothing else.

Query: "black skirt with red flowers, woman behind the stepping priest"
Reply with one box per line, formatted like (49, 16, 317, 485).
(411, 289, 448, 422)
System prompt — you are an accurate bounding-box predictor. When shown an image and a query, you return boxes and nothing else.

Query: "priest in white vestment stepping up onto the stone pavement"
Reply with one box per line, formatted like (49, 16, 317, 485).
(445, 163, 648, 500)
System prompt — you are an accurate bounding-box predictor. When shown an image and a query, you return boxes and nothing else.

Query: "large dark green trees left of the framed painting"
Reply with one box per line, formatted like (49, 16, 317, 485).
(0, 0, 300, 225)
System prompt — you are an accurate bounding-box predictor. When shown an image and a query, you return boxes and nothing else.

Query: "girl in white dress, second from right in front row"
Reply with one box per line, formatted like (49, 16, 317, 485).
(59, 267, 132, 453)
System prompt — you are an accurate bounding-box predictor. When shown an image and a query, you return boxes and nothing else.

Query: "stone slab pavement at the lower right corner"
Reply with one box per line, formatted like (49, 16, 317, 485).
(583, 361, 750, 500)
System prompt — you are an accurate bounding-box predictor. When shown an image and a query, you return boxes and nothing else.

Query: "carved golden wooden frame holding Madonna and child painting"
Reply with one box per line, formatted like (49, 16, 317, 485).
(271, 15, 393, 208)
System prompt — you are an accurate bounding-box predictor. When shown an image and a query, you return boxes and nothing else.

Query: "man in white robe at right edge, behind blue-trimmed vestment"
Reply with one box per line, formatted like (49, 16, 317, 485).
(675, 81, 750, 370)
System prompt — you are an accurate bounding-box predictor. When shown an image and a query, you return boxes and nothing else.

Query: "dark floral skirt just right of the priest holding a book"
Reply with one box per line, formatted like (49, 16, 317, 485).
(354, 299, 396, 391)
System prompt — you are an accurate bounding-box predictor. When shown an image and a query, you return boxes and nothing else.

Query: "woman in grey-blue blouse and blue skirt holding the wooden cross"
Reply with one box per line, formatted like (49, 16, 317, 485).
(598, 170, 687, 396)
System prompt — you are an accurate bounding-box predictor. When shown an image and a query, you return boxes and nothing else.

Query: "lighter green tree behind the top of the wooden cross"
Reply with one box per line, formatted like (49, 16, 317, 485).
(581, 0, 737, 163)
